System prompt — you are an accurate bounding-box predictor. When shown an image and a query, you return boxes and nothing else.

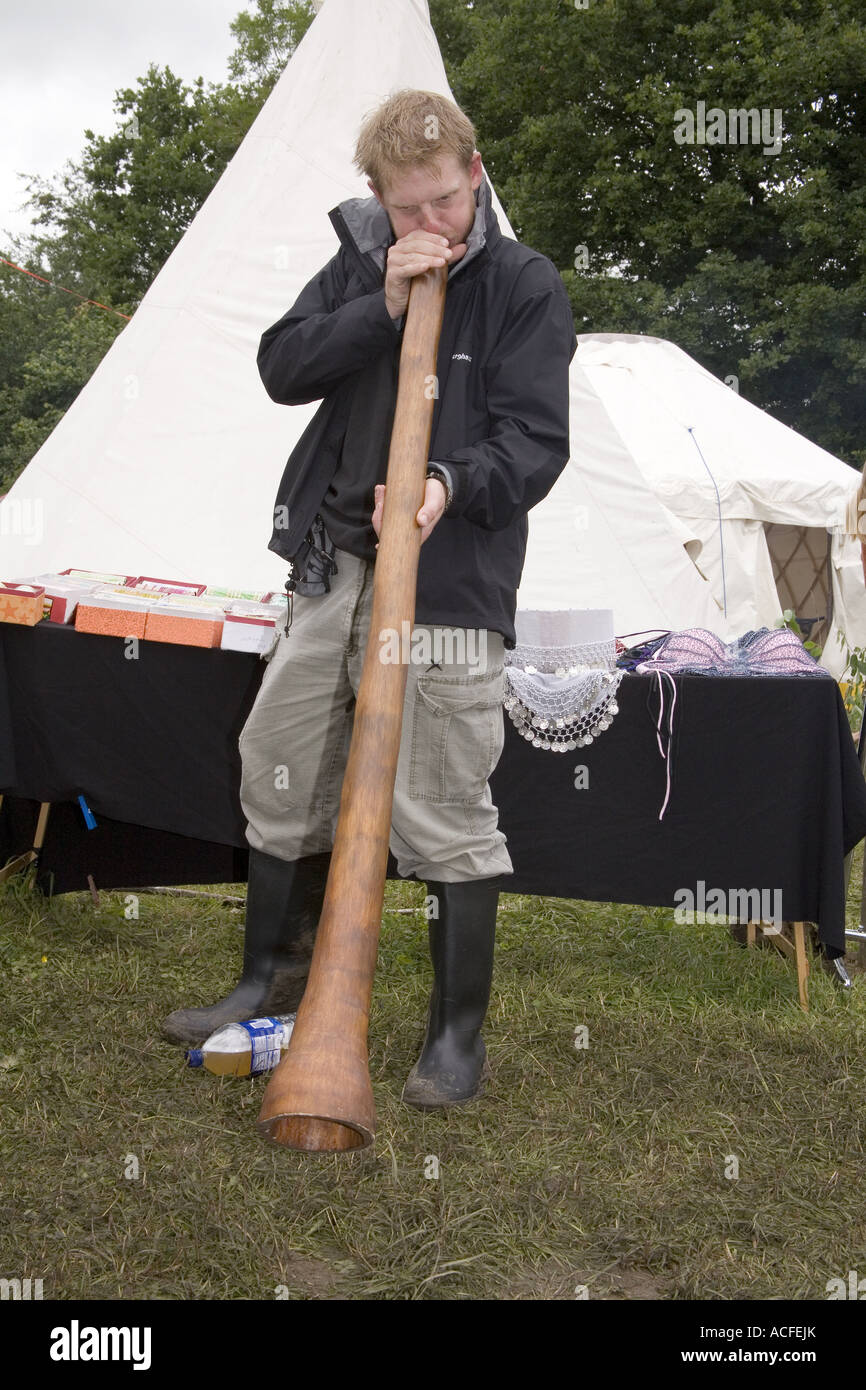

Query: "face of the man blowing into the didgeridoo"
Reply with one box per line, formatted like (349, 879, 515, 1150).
(368, 150, 482, 246)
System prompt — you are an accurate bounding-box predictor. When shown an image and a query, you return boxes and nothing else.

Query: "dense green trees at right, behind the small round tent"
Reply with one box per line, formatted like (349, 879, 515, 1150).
(431, 0, 866, 464)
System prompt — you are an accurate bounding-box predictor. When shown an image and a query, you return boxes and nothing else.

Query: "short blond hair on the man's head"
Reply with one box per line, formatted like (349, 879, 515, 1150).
(354, 88, 475, 193)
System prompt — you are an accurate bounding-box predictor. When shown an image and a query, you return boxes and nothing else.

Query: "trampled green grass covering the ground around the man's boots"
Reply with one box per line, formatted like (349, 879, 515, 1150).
(0, 851, 866, 1300)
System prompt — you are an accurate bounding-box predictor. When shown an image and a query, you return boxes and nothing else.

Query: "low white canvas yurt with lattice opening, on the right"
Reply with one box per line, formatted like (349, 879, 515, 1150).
(520, 334, 866, 674)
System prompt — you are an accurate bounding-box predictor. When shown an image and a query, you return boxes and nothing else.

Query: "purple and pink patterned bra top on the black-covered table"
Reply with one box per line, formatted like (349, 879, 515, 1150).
(635, 627, 833, 680)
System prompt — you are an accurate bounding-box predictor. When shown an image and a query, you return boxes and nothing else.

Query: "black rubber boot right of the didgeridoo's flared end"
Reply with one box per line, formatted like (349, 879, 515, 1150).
(403, 878, 499, 1111)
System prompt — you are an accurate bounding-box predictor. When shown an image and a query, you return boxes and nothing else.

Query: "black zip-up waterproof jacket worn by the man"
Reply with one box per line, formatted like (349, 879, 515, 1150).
(257, 181, 577, 648)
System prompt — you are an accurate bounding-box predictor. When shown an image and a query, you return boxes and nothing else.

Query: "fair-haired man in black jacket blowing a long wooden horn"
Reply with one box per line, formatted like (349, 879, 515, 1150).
(164, 90, 575, 1109)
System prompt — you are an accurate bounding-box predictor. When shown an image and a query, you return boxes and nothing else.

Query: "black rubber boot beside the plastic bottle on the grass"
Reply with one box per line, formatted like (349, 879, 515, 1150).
(163, 849, 331, 1043)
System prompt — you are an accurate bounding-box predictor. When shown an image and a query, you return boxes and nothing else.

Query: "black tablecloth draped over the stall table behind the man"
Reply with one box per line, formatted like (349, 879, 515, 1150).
(0, 624, 866, 955)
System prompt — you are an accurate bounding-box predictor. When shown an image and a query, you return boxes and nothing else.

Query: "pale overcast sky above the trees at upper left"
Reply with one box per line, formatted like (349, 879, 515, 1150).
(0, 0, 250, 246)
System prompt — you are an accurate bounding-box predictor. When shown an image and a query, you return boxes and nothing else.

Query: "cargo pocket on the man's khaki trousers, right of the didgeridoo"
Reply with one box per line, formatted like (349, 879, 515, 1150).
(409, 667, 505, 805)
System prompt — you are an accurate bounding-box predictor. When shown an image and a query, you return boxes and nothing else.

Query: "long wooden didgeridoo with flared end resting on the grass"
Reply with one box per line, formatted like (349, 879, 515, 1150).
(257, 265, 448, 1154)
